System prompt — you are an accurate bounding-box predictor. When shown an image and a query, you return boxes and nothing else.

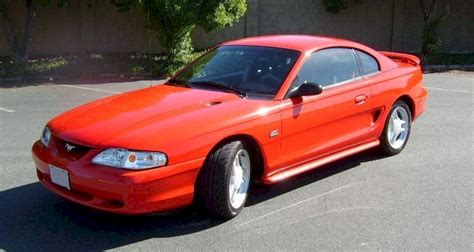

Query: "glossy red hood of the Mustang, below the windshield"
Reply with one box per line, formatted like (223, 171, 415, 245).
(49, 85, 271, 150)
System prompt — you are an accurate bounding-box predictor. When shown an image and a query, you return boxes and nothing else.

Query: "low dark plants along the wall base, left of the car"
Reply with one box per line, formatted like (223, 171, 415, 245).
(0, 51, 206, 79)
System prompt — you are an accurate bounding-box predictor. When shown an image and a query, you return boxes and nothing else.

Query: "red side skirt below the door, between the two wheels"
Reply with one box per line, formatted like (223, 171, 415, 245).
(263, 139, 380, 184)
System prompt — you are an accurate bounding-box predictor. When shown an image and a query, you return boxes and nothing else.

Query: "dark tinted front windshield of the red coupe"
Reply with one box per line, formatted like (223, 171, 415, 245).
(173, 46, 300, 97)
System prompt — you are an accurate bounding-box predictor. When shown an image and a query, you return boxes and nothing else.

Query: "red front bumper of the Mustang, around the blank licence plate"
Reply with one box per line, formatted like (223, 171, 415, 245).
(32, 141, 204, 214)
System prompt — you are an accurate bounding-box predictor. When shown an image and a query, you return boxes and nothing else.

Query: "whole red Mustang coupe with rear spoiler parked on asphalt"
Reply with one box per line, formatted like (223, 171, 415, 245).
(33, 35, 427, 218)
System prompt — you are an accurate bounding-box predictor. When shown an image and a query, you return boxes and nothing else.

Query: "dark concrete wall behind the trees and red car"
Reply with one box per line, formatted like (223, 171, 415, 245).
(0, 0, 474, 56)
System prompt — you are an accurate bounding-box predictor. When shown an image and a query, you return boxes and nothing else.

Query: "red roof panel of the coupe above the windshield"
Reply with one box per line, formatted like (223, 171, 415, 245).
(222, 35, 351, 52)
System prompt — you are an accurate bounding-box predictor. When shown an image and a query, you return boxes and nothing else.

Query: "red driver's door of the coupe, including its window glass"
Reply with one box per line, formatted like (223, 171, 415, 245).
(281, 48, 372, 167)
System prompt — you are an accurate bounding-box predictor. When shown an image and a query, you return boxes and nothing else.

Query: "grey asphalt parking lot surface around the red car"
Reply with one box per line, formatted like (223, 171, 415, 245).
(0, 72, 474, 251)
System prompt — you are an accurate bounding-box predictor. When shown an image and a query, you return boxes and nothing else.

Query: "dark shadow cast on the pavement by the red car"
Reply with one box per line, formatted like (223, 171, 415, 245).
(0, 151, 383, 251)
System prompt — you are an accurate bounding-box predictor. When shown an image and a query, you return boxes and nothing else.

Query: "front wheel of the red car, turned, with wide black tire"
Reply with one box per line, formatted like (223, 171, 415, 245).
(196, 141, 252, 219)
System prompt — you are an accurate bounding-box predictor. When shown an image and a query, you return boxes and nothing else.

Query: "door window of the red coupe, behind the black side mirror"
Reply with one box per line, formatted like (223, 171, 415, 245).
(297, 48, 360, 87)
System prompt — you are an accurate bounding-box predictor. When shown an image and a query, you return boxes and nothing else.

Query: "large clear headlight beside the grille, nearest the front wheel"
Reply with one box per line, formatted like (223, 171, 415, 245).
(92, 148, 167, 170)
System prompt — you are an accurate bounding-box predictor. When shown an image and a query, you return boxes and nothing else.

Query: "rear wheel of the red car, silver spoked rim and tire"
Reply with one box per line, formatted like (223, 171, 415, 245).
(380, 101, 412, 156)
